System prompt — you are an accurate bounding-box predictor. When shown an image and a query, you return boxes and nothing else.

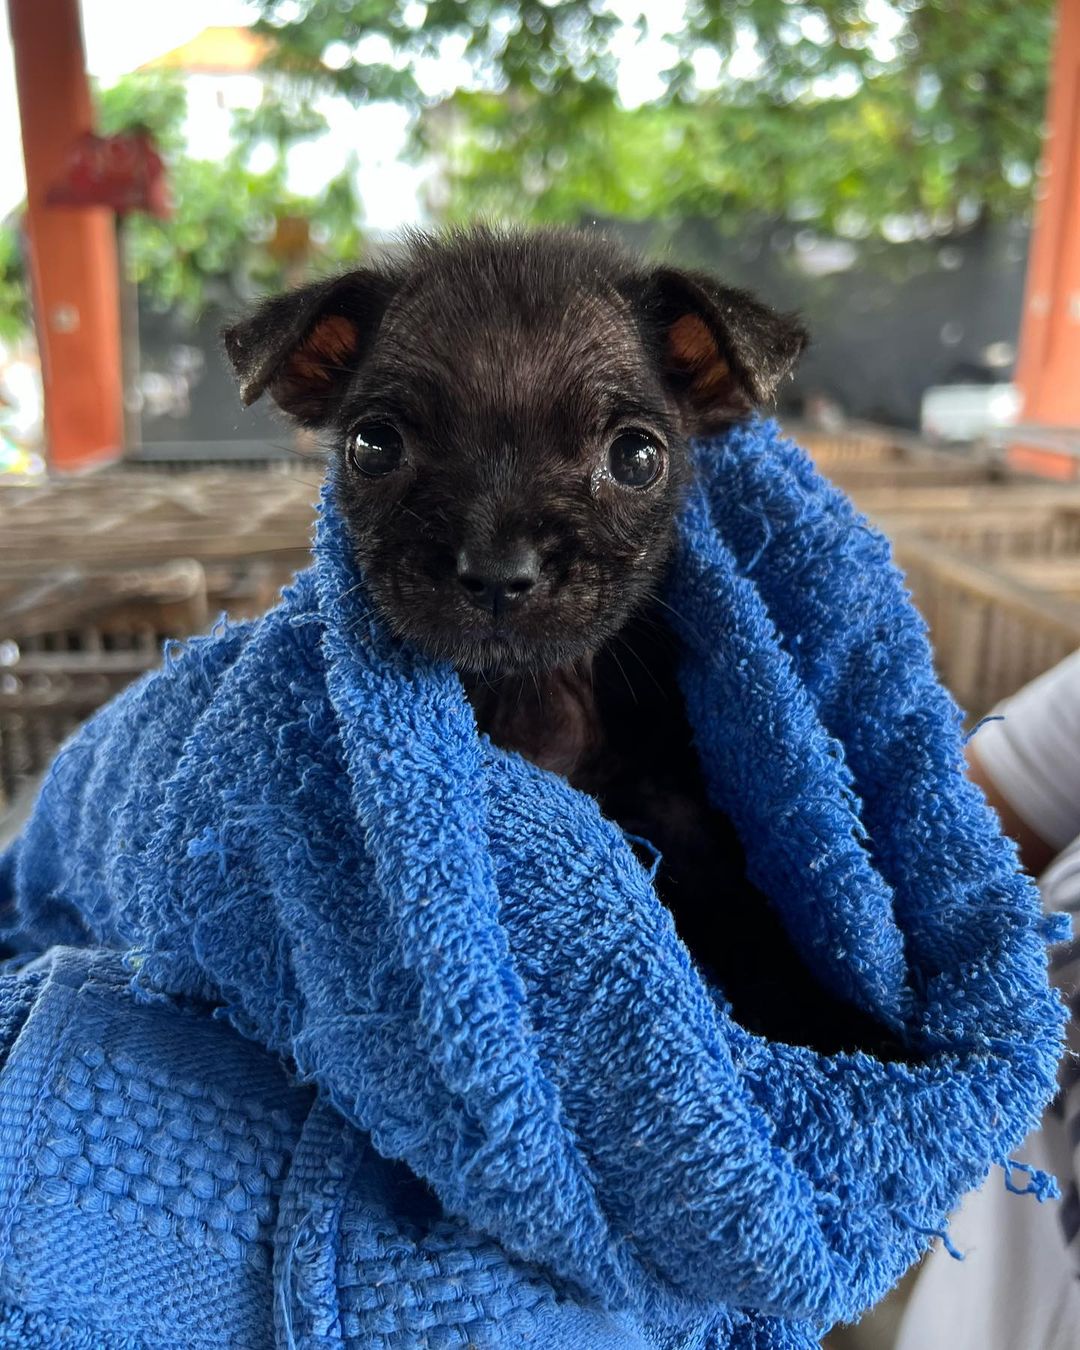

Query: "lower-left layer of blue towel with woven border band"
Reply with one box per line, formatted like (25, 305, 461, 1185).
(0, 948, 705, 1350)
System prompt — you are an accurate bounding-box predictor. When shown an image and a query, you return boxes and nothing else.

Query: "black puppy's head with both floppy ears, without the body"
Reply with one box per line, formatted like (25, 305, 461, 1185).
(225, 232, 805, 672)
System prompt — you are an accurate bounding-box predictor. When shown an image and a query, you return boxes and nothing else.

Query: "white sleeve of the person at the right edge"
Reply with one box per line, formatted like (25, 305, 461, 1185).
(973, 651, 1080, 852)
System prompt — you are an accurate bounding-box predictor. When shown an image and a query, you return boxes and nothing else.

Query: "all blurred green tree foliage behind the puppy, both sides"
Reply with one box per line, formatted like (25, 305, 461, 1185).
(0, 0, 1053, 336)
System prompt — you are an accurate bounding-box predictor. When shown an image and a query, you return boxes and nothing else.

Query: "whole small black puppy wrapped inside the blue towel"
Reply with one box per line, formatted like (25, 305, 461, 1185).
(224, 230, 896, 1049)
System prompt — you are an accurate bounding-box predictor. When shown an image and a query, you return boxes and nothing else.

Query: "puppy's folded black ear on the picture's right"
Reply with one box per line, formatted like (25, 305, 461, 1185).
(644, 267, 809, 432)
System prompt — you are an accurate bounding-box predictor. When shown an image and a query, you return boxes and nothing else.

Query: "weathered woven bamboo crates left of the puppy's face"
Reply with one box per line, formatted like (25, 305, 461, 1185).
(0, 467, 319, 813)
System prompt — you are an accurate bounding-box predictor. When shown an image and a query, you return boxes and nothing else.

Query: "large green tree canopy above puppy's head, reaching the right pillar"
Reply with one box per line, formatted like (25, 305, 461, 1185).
(259, 0, 1053, 236)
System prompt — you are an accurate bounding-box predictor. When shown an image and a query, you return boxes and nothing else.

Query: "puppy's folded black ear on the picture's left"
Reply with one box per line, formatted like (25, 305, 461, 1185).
(221, 267, 398, 427)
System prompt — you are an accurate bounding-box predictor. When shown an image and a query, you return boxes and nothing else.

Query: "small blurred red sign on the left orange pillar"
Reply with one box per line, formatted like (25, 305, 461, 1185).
(46, 131, 173, 217)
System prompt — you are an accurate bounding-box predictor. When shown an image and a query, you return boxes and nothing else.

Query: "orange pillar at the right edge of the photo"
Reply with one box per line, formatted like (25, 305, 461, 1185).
(1010, 0, 1080, 478)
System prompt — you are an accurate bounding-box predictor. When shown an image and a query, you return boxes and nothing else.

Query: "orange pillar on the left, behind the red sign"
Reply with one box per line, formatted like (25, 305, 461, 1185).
(9, 0, 123, 470)
